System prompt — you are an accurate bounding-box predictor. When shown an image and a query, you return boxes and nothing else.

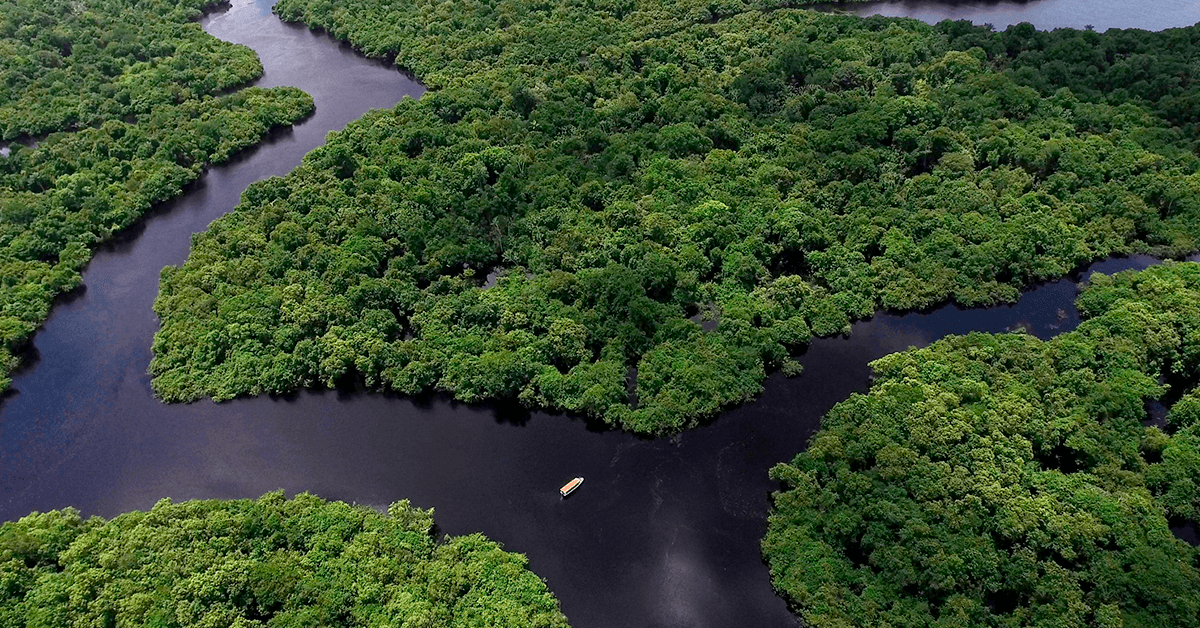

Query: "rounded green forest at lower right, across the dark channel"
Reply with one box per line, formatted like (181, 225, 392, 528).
(763, 263, 1200, 628)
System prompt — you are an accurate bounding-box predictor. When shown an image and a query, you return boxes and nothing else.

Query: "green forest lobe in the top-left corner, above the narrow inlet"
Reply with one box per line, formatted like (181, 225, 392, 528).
(0, 0, 263, 139)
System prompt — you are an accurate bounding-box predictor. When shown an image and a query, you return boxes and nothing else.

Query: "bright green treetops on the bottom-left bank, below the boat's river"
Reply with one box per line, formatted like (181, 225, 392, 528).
(0, 491, 566, 628)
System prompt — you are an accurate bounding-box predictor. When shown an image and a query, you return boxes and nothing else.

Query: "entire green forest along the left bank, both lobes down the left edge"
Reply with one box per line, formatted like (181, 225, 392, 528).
(0, 0, 312, 390)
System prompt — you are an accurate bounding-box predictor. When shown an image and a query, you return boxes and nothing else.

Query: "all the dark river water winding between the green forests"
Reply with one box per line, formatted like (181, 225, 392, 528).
(7, 0, 1200, 628)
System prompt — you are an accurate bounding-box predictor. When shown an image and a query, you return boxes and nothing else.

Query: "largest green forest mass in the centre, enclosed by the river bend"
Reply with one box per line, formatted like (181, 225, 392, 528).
(151, 0, 1200, 433)
